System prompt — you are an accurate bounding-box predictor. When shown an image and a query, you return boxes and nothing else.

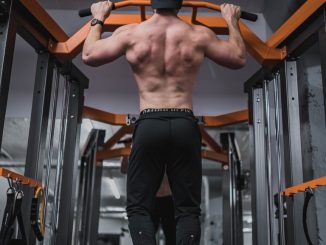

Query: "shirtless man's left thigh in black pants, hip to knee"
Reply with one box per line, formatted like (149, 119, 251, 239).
(127, 119, 167, 214)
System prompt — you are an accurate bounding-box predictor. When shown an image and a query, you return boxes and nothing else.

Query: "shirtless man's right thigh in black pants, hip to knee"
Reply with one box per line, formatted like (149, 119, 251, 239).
(167, 118, 202, 218)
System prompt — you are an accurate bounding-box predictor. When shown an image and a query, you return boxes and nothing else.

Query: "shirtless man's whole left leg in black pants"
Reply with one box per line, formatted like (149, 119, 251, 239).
(127, 119, 168, 245)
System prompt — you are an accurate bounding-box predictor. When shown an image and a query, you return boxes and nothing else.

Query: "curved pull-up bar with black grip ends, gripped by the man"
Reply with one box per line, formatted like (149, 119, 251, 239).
(78, 1, 258, 21)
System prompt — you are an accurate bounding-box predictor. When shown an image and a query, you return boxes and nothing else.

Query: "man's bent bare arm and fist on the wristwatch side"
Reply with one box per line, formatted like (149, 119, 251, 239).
(82, 1, 135, 66)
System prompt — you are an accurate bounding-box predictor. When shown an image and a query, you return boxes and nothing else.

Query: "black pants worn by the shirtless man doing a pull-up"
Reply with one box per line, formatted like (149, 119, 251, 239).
(127, 109, 202, 245)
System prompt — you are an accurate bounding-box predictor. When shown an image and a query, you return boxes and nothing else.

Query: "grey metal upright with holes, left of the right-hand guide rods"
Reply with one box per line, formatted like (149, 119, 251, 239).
(249, 88, 270, 245)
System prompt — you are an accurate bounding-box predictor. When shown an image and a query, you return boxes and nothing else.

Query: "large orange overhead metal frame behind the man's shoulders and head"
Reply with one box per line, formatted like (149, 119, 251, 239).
(21, 0, 326, 64)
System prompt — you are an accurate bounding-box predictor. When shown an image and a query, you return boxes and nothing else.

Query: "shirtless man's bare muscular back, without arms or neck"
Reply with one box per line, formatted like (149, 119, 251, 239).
(126, 16, 204, 109)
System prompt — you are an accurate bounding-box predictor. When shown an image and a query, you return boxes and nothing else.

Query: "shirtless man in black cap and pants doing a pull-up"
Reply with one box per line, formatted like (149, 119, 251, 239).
(83, 0, 246, 242)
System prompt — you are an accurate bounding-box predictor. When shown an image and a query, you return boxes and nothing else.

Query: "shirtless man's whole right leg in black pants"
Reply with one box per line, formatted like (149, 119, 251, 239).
(167, 118, 202, 245)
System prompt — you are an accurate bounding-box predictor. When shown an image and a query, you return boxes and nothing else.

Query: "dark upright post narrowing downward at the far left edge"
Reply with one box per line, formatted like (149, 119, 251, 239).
(0, 1, 17, 149)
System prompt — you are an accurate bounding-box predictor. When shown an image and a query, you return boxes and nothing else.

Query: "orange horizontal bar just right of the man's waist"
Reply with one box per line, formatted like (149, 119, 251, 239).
(204, 110, 249, 127)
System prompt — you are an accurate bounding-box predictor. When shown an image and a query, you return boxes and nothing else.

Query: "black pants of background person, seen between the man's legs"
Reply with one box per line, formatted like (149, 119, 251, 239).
(152, 196, 177, 245)
